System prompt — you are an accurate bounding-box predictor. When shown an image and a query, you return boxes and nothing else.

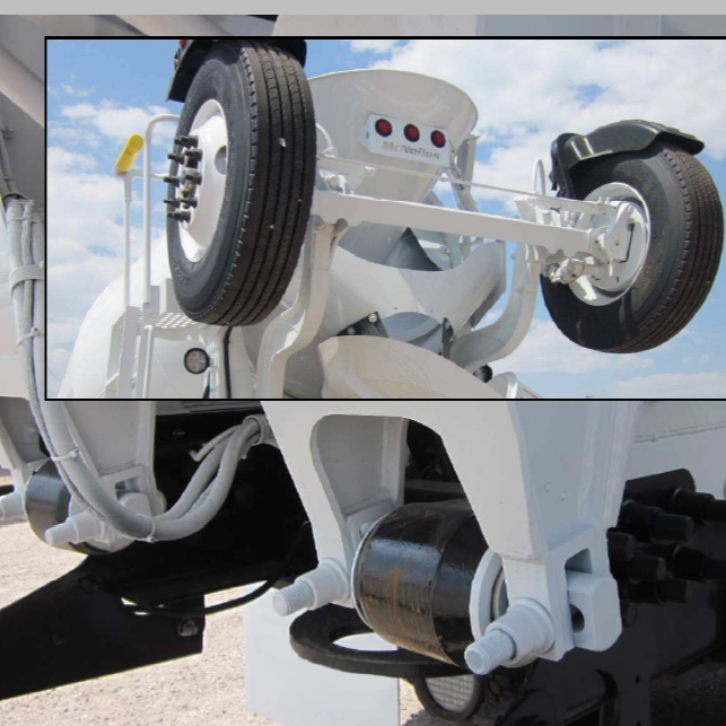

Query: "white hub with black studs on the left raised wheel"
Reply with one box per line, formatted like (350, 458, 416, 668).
(172, 100, 229, 262)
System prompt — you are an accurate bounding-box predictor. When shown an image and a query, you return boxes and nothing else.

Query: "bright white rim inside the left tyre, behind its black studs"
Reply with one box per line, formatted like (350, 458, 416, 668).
(179, 100, 229, 262)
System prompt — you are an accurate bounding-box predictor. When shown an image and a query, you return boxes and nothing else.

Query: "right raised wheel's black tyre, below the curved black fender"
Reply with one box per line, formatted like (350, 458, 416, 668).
(542, 144, 724, 353)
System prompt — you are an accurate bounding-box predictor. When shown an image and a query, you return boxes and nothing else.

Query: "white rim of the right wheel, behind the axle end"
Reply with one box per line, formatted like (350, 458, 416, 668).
(570, 182, 651, 307)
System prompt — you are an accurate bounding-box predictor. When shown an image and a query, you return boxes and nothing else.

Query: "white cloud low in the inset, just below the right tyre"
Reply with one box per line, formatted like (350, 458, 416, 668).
(499, 320, 655, 374)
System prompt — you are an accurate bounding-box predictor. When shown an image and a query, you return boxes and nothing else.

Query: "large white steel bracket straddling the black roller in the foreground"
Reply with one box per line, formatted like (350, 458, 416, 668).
(263, 401, 640, 660)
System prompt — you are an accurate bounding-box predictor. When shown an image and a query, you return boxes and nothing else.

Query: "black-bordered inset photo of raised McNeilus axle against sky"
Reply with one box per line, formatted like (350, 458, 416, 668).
(0, 34, 708, 400)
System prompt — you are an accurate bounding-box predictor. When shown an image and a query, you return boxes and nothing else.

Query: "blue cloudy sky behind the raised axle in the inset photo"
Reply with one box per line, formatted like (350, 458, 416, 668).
(48, 39, 726, 398)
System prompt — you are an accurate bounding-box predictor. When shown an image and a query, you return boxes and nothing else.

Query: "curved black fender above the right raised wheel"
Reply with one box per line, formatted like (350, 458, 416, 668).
(550, 121, 706, 197)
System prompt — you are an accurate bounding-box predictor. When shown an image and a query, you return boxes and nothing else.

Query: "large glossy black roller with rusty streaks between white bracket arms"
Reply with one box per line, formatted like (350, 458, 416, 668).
(353, 500, 487, 667)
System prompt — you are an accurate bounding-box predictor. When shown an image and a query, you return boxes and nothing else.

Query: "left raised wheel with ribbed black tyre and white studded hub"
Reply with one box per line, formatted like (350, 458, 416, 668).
(167, 40, 316, 326)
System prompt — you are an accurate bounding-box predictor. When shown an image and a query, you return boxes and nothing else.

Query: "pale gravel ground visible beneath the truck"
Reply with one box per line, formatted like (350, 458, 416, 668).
(0, 480, 726, 726)
